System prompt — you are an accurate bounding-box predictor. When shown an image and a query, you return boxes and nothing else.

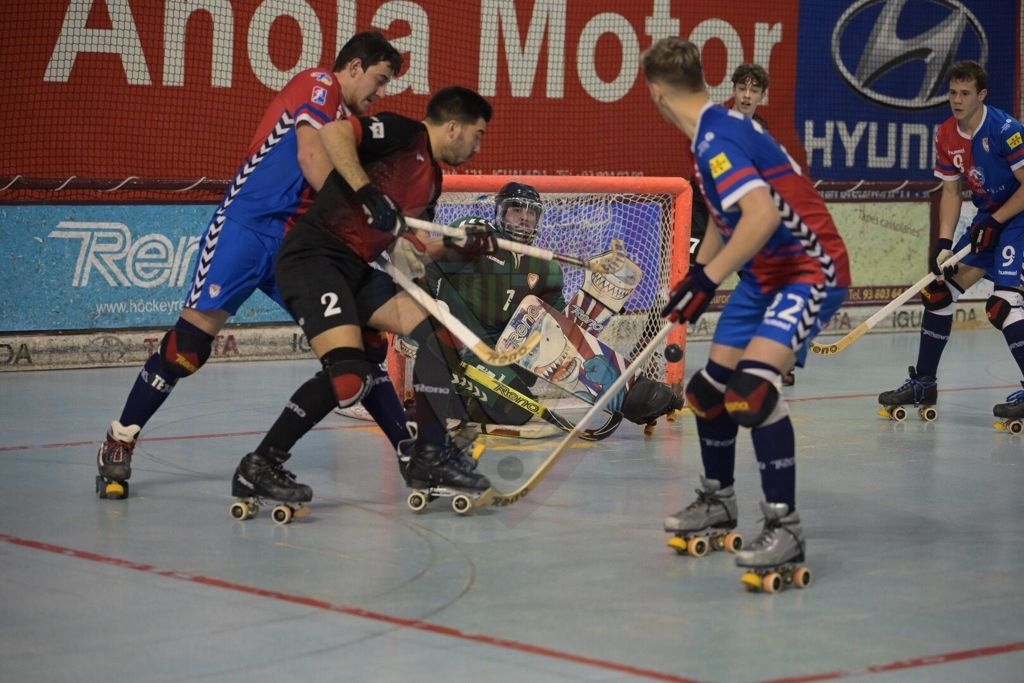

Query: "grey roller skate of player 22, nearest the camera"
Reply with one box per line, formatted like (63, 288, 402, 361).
(736, 502, 811, 593)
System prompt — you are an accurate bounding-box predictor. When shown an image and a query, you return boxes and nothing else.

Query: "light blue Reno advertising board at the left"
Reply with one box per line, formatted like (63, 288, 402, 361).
(0, 205, 290, 332)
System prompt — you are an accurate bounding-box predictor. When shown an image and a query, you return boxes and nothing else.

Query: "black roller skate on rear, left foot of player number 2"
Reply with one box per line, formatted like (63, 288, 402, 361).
(231, 449, 313, 524)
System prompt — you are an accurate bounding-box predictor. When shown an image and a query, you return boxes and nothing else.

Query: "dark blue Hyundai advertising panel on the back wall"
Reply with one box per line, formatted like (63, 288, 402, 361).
(796, 0, 1020, 181)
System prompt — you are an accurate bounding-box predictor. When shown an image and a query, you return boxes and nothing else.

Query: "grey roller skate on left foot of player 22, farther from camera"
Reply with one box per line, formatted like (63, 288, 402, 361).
(665, 477, 743, 557)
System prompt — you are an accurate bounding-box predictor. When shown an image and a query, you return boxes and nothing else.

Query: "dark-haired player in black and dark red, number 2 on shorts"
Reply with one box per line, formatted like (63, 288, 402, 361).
(231, 87, 497, 502)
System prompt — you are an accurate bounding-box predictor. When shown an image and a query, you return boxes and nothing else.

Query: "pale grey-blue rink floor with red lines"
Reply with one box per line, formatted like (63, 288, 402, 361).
(0, 329, 1024, 683)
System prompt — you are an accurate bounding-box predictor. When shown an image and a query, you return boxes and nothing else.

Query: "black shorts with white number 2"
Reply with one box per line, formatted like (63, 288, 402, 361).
(276, 225, 398, 339)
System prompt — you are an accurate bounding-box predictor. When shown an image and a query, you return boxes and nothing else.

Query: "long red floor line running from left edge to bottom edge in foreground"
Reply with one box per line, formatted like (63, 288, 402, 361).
(0, 533, 697, 683)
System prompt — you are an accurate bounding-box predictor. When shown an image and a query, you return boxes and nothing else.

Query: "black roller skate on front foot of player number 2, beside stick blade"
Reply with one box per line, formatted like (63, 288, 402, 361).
(402, 443, 490, 515)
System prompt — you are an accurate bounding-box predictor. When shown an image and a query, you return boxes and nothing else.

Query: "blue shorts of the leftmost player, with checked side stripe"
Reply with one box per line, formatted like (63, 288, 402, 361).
(184, 217, 287, 315)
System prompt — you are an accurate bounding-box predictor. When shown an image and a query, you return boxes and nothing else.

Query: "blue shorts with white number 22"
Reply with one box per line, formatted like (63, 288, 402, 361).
(713, 280, 849, 368)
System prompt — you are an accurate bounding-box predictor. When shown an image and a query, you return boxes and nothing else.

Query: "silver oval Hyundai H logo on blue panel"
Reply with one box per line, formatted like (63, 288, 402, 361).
(831, 0, 988, 110)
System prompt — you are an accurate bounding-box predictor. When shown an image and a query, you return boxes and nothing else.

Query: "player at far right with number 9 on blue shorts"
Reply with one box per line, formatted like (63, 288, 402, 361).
(879, 61, 1024, 419)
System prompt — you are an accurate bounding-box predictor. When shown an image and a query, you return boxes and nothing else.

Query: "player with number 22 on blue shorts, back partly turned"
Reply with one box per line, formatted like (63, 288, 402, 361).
(643, 38, 850, 581)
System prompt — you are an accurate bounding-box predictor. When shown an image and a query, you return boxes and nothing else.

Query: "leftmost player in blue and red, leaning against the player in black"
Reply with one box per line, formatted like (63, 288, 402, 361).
(96, 32, 406, 498)
